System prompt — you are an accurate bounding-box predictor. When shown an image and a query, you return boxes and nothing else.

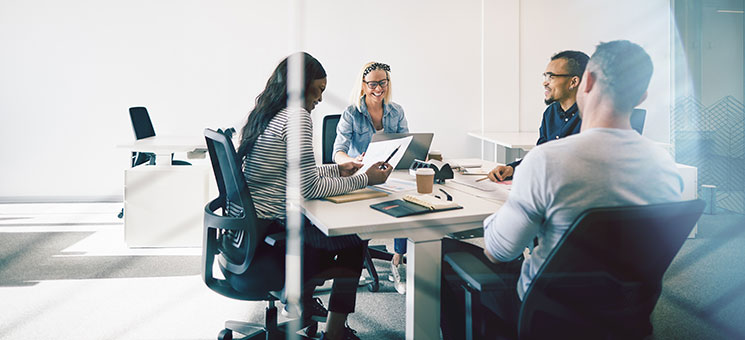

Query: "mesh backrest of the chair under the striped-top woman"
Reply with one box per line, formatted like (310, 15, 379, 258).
(203, 129, 265, 275)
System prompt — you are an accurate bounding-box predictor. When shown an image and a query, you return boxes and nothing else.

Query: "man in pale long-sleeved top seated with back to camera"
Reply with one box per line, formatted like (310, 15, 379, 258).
(441, 40, 683, 340)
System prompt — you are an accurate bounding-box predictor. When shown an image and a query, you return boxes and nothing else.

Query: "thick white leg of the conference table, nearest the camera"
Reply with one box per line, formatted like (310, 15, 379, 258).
(406, 239, 442, 340)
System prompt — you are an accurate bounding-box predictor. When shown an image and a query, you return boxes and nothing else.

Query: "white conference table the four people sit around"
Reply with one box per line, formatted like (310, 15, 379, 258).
(303, 165, 503, 339)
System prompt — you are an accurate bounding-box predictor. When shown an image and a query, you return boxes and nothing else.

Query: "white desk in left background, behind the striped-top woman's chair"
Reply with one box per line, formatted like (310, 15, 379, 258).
(119, 136, 217, 247)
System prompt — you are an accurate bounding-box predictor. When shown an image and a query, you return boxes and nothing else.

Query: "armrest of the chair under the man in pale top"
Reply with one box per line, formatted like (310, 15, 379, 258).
(444, 252, 503, 292)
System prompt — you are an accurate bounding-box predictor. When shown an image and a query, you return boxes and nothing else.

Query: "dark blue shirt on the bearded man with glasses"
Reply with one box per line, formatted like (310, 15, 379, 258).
(507, 102, 582, 168)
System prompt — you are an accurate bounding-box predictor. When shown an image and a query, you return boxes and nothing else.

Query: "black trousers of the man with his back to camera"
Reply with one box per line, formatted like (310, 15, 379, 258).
(440, 239, 523, 339)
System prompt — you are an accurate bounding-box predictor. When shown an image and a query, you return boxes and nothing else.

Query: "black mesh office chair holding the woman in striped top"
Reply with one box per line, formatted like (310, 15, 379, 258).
(202, 129, 318, 340)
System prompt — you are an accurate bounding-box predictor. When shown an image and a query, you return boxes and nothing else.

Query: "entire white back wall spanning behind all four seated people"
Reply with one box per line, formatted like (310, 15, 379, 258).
(0, 0, 670, 201)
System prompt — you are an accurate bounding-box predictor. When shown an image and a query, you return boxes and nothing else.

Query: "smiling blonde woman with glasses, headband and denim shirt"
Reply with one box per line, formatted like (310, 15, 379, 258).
(333, 62, 409, 294)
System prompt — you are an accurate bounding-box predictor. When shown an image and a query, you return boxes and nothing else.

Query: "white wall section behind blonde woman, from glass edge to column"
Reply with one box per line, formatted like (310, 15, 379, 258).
(305, 0, 481, 167)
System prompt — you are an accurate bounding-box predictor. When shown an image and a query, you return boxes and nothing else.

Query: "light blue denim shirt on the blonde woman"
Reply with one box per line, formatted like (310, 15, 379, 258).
(333, 96, 409, 157)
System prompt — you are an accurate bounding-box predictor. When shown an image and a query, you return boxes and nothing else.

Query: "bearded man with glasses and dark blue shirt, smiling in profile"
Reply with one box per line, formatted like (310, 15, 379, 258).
(489, 51, 590, 182)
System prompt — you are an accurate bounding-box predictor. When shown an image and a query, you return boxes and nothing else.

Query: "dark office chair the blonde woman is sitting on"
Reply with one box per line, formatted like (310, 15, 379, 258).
(321, 114, 396, 292)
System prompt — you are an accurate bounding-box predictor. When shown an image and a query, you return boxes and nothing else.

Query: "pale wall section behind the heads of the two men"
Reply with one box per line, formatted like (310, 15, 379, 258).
(519, 0, 671, 142)
